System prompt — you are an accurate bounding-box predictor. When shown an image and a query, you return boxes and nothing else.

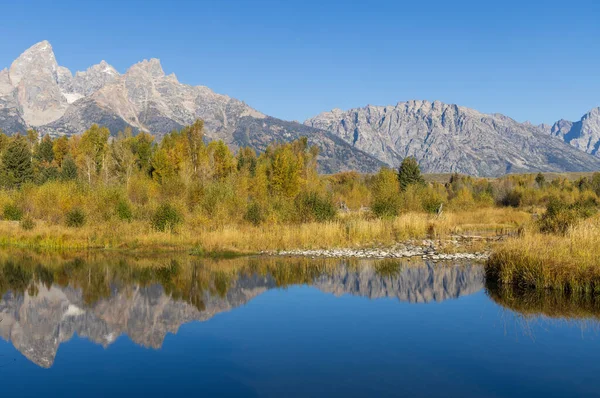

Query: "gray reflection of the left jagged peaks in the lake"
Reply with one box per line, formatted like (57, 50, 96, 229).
(0, 278, 265, 367)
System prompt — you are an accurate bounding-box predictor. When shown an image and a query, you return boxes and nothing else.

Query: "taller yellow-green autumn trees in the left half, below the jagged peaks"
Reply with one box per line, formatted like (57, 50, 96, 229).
(0, 120, 335, 229)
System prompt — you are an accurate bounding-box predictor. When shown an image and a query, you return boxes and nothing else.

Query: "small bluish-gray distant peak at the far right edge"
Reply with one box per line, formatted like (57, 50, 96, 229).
(546, 107, 600, 157)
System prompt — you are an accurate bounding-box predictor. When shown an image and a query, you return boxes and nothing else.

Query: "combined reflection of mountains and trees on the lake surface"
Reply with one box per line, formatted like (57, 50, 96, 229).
(0, 257, 483, 367)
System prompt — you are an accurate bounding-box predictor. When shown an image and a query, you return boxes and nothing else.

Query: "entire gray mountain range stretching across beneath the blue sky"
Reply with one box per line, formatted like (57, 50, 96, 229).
(0, 41, 600, 176)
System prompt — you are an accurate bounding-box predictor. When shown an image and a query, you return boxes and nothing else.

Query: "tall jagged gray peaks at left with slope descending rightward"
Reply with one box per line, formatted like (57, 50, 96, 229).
(0, 41, 382, 172)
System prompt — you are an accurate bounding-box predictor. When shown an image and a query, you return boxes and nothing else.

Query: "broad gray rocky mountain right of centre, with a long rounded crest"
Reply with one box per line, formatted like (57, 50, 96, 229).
(305, 101, 600, 176)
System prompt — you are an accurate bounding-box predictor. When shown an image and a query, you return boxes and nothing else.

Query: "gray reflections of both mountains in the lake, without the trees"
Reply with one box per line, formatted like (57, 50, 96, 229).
(0, 262, 484, 368)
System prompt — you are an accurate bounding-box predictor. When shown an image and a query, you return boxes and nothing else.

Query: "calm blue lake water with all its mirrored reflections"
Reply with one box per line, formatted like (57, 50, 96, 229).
(0, 252, 600, 397)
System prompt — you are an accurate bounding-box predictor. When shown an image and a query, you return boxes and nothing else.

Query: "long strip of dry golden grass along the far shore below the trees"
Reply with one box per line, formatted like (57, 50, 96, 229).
(0, 208, 530, 253)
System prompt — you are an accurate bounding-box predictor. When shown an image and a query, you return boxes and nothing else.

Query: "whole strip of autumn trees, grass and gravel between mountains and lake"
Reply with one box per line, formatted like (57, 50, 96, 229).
(0, 121, 600, 291)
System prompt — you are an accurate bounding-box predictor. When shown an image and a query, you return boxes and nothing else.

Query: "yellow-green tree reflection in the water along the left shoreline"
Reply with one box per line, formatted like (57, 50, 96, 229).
(0, 251, 350, 310)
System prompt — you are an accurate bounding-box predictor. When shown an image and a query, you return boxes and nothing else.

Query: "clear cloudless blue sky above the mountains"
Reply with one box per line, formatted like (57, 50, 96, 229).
(0, 0, 600, 123)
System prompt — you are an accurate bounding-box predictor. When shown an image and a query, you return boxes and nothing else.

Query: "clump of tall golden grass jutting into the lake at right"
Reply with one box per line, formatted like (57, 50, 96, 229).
(486, 217, 600, 292)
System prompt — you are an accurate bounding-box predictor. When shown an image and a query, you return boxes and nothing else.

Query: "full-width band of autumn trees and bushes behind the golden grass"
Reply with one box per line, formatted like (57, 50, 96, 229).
(0, 120, 600, 231)
